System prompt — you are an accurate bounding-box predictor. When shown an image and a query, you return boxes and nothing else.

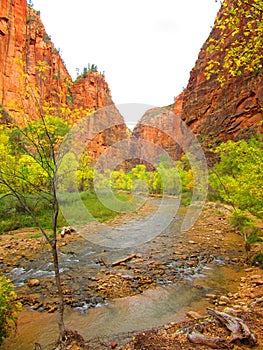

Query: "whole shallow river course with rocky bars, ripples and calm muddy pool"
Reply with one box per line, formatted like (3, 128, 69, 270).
(0, 198, 248, 350)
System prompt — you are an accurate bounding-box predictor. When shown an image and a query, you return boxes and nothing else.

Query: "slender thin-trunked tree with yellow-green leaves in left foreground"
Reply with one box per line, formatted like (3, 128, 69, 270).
(0, 62, 89, 339)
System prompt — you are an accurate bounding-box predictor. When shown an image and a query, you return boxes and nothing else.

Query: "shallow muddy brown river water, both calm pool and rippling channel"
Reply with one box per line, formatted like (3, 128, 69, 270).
(2, 200, 246, 350)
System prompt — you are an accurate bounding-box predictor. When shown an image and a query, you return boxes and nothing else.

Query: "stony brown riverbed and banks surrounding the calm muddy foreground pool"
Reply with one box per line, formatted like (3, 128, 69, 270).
(0, 203, 263, 349)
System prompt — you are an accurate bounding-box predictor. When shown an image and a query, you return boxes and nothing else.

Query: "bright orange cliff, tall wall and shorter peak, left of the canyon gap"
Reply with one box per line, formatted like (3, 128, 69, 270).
(0, 0, 127, 157)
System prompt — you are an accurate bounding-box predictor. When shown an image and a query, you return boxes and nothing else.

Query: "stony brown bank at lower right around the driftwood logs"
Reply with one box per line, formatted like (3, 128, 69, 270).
(120, 267, 263, 350)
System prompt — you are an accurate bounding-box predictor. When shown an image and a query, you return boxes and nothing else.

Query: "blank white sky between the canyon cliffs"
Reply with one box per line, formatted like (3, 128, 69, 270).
(33, 0, 220, 126)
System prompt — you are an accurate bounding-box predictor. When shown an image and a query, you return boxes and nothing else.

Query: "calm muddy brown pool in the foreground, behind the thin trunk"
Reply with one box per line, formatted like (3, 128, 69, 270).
(3, 266, 245, 350)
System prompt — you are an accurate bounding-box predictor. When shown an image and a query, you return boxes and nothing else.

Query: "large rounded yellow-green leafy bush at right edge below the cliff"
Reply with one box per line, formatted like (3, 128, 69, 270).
(210, 136, 263, 217)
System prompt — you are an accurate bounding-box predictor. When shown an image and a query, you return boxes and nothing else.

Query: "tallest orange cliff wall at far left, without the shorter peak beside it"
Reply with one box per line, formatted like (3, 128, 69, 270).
(0, 0, 70, 112)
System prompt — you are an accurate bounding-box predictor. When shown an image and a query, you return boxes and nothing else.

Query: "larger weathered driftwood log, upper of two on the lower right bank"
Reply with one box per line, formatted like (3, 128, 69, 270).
(207, 308, 256, 346)
